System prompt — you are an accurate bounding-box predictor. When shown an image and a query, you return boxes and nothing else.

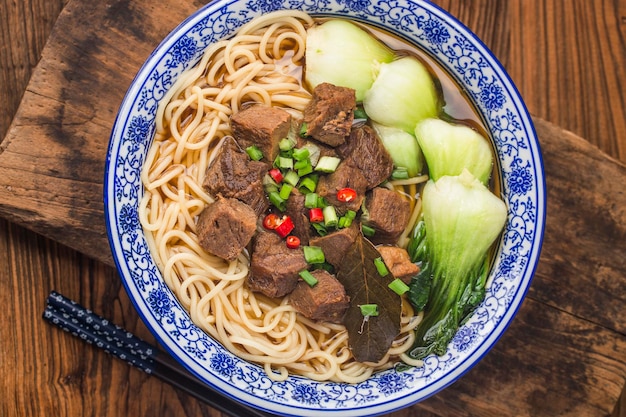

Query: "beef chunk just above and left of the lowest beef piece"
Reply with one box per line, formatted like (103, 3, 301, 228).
(248, 232, 308, 297)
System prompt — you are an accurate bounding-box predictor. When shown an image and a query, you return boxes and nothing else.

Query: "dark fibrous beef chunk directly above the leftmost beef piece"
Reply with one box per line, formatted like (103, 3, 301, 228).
(202, 137, 269, 216)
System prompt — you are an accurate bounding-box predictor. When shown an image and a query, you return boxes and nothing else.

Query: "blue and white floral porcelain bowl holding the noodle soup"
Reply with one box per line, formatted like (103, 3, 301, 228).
(104, 0, 546, 417)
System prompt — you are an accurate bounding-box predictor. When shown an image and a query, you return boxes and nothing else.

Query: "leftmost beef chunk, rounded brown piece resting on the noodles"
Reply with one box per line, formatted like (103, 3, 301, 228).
(196, 198, 257, 261)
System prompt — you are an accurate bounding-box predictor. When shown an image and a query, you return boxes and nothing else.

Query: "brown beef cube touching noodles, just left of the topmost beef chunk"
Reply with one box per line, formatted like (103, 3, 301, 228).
(230, 104, 291, 162)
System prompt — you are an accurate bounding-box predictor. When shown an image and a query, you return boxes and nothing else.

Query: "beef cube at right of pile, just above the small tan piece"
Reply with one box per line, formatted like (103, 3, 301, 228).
(365, 187, 411, 244)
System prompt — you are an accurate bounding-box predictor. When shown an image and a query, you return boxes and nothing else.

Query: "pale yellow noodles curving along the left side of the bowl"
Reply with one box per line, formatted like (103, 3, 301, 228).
(139, 11, 419, 383)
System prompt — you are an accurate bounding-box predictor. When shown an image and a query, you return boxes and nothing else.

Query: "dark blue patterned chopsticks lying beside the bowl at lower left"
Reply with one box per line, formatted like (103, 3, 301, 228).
(43, 291, 274, 417)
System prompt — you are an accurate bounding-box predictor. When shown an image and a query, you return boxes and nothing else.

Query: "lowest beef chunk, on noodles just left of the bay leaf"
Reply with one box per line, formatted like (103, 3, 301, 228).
(289, 269, 350, 323)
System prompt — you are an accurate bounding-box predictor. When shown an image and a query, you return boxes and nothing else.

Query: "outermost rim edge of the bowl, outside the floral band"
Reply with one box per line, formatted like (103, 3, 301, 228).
(103, 0, 546, 415)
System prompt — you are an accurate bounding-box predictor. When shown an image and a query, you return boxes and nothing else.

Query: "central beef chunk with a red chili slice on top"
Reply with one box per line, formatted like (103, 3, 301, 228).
(316, 162, 367, 215)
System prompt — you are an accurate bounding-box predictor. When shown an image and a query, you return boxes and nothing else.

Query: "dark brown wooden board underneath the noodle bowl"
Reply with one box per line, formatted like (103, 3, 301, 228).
(0, 0, 626, 415)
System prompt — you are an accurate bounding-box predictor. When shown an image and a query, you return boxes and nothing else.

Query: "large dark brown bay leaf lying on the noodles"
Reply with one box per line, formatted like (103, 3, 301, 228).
(337, 234, 402, 362)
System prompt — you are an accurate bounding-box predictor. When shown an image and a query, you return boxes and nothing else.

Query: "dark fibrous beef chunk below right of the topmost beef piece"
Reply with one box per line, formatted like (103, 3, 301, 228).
(337, 125, 393, 190)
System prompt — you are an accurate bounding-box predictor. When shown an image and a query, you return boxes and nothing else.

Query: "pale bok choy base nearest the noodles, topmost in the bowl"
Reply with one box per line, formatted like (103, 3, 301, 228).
(304, 19, 395, 102)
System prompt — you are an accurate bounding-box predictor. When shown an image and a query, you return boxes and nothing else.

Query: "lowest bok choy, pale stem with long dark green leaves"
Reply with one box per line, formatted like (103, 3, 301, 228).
(409, 170, 507, 359)
